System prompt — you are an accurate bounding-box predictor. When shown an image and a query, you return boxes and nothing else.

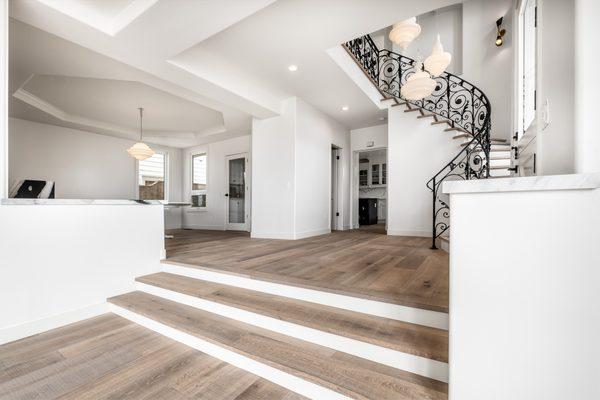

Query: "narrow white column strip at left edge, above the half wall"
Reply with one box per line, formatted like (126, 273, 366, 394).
(0, 1, 8, 199)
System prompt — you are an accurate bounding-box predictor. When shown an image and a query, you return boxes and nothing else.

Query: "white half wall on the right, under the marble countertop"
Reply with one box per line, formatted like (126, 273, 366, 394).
(449, 175, 600, 400)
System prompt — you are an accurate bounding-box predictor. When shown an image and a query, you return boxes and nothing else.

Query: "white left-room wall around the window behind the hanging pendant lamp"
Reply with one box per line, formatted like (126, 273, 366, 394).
(9, 118, 182, 228)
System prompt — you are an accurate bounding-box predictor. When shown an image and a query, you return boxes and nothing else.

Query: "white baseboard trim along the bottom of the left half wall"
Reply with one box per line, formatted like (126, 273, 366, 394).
(0, 302, 108, 345)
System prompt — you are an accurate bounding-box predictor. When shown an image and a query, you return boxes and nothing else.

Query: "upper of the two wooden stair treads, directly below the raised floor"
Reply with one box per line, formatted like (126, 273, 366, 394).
(136, 272, 448, 362)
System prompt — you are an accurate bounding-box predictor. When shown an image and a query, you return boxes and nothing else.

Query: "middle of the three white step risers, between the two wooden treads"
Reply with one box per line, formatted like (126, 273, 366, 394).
(136, 282, 448, 383)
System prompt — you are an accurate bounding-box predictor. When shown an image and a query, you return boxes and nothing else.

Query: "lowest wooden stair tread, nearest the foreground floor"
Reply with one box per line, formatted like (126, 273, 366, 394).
(109, 292, 448, 400)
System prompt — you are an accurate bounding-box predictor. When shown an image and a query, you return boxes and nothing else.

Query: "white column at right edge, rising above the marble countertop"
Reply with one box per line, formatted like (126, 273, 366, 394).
(572, 0, 600, 173)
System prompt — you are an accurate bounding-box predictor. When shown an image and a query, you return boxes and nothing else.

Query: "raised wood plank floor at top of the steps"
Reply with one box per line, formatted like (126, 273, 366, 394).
(166, 229, 448, 312)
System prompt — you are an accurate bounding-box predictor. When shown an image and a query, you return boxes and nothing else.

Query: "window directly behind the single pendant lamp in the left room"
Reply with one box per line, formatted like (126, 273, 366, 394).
(138, 153, 167, 200)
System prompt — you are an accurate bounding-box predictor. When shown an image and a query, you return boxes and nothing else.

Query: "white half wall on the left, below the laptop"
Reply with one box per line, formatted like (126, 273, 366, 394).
(0, 200, 164, 343)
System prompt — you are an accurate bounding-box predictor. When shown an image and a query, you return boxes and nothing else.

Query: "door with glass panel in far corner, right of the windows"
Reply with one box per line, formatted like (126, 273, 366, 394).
(225, 154, 249, 231)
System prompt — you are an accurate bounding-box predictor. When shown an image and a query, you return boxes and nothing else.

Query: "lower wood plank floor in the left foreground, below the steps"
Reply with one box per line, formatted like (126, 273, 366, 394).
(0, 314, 304, 400)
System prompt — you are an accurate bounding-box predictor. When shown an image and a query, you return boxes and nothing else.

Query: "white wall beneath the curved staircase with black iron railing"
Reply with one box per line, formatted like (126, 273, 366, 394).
(387, 107, 461, 237)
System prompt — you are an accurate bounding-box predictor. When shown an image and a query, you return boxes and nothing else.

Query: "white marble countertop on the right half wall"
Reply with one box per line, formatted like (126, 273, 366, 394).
(442, 173, 600, 194)
